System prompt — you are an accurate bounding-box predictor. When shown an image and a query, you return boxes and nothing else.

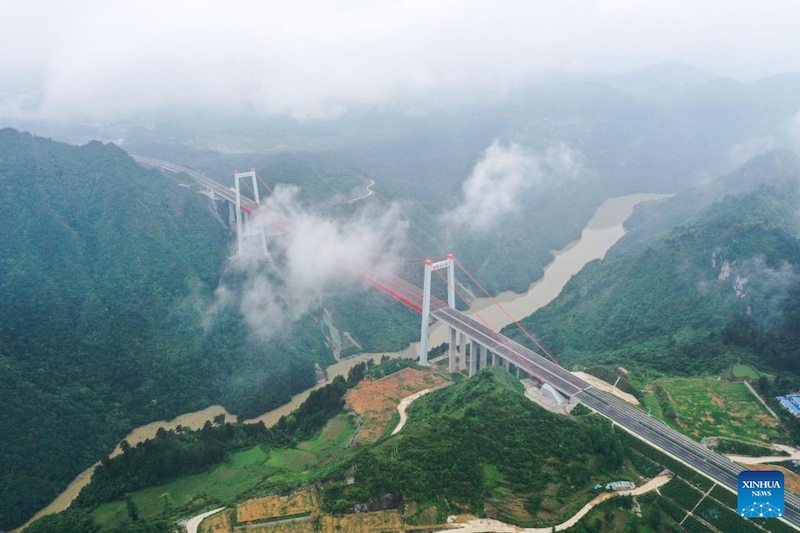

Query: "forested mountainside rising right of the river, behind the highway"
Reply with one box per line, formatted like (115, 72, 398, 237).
(512, 177, 800, 374)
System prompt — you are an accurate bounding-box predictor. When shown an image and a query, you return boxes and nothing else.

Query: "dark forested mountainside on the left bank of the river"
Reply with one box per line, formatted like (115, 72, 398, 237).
(0, 129, 331, 529)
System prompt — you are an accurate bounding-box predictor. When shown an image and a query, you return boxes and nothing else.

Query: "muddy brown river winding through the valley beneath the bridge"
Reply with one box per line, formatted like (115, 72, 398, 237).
(17, 190, 670, 533)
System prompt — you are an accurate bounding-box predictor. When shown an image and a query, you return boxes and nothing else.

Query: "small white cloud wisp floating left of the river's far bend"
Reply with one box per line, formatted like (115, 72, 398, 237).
(441, 140, 582, 232)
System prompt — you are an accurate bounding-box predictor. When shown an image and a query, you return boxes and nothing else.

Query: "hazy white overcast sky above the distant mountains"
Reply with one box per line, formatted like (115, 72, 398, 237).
(0, 0, 800, 118)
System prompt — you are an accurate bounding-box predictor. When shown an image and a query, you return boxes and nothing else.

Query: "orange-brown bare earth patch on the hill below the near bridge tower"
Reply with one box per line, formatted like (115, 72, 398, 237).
(345, 368, 454, 442)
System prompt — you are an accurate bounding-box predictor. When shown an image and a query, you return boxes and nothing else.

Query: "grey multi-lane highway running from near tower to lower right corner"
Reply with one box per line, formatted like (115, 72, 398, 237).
(431, 307, 800, 528)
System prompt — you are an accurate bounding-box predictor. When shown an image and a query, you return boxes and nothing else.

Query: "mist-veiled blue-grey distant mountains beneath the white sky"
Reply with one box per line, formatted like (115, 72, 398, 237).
(89, 62, 800, 291)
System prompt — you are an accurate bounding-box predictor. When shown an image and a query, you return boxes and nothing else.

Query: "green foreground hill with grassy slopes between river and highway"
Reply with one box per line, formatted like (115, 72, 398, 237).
(32, 366, 636, 532)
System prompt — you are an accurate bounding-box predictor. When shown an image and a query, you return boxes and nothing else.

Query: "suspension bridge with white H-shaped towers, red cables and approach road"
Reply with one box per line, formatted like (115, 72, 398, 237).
(133, 156, 800, 529)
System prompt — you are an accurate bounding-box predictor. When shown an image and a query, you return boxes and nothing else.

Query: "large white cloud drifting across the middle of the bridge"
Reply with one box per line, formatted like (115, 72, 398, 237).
(213, 185, 408, 339)
